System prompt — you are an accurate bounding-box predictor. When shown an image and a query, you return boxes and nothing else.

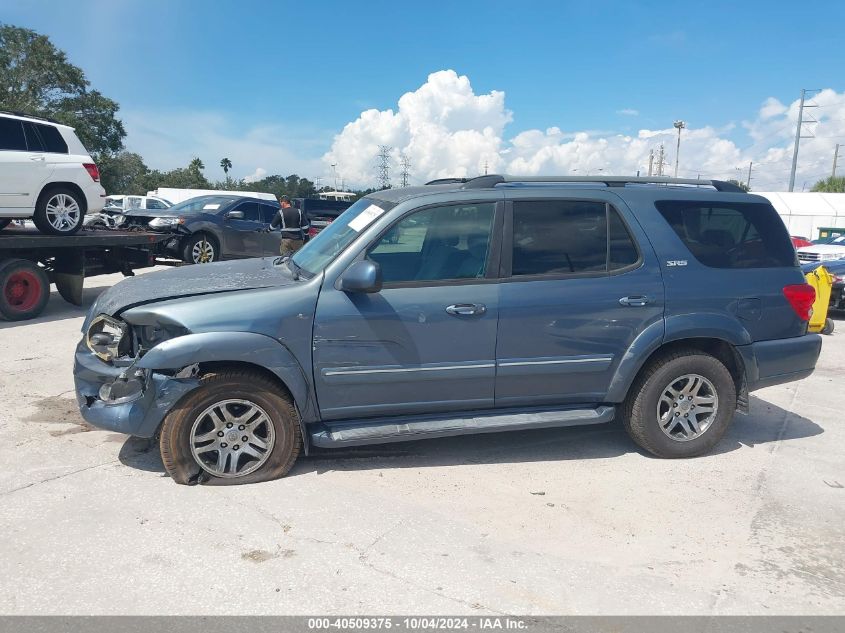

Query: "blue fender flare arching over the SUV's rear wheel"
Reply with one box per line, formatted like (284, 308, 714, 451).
(606, 313, 752, 403)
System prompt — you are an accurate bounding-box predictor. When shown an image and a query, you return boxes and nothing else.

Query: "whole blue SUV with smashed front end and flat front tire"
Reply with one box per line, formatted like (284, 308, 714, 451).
(74, 176, 821, 484)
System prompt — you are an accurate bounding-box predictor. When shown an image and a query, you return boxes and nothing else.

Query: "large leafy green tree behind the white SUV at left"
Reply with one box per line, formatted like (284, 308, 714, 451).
(0, 23, 126, 156)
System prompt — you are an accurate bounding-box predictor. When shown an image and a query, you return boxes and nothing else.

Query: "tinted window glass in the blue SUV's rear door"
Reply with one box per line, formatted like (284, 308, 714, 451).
(511, 200, 639, 277)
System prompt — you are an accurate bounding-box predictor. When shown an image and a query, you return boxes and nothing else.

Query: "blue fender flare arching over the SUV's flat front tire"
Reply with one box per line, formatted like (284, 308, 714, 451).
(138, 332, 318, 428)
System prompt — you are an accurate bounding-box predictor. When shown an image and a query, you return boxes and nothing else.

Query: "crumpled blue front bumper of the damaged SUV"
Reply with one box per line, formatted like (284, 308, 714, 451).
(73, 340, 199, 437)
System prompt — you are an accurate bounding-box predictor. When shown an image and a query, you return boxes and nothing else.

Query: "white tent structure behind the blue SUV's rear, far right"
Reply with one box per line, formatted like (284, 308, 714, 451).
(752, 191, 845, 240)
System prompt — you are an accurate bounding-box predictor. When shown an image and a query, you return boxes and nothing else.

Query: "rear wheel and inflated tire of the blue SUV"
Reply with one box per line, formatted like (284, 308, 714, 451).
(623, 348, 736, 458)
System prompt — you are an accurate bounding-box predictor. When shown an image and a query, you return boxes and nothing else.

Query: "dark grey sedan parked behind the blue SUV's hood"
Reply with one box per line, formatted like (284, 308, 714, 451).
(125, 196, 281, 264)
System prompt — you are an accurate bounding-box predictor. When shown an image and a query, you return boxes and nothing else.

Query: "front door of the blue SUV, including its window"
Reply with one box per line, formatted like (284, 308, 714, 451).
(314, 202, 503, 420)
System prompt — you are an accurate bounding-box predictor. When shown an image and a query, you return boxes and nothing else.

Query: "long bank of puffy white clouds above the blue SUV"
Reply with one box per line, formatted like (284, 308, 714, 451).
(323, 70, 845, 191)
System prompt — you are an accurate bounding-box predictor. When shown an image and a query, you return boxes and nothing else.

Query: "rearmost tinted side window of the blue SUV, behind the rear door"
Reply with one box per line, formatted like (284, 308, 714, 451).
(656, 200, 796, 268)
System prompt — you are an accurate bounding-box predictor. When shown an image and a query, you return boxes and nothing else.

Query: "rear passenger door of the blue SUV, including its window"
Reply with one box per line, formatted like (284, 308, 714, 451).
(496, 192, 664, 407)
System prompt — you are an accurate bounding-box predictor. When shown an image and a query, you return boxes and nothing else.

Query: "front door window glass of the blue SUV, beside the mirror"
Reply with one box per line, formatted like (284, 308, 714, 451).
(369, 203, 495, 282)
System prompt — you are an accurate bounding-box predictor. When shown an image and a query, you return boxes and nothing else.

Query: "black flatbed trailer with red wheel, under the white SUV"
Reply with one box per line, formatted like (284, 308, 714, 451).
(0, 227, 168, 321)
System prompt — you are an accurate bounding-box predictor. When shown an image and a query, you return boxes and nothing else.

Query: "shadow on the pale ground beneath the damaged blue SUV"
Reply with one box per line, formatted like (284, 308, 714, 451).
(119, 397, 824, 477)
